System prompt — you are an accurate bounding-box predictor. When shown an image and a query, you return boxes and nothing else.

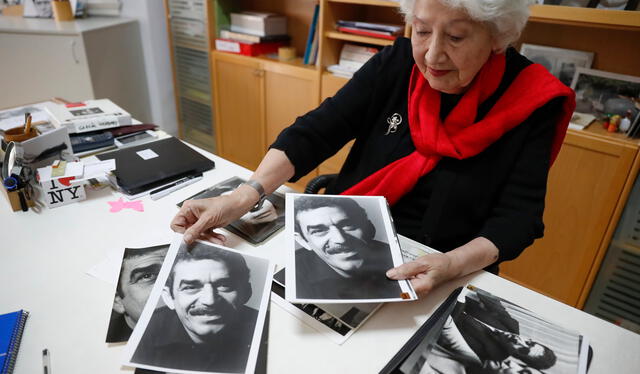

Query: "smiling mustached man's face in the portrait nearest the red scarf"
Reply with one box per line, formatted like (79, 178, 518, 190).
(296, 206, 371, 276)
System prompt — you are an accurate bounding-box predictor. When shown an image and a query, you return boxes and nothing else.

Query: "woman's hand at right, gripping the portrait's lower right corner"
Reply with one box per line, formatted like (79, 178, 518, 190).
(387, 253, 458, 296)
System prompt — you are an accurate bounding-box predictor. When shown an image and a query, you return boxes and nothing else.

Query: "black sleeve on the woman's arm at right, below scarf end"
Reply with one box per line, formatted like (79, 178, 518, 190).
(479, 98, 564, 263)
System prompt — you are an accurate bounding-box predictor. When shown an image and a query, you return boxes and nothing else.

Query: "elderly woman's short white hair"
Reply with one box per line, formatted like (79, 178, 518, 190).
(400, 0, 535, 51)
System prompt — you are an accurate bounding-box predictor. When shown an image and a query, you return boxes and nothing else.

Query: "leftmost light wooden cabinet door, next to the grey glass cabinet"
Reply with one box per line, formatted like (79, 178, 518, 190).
(213, 52, 265, 170)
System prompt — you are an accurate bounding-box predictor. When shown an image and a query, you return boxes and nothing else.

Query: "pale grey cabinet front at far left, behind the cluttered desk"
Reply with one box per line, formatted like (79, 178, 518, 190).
(0, 33, 94, 108)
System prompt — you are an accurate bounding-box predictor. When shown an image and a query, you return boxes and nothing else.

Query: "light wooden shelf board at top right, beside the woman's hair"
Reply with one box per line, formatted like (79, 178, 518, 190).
(529, 5, 640, 31)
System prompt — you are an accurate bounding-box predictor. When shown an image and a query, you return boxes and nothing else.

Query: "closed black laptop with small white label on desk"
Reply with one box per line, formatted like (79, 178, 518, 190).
(97, 137, 215, 195)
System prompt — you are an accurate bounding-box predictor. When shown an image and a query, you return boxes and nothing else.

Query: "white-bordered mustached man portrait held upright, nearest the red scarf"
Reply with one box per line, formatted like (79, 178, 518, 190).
(286, 194, 416, 303)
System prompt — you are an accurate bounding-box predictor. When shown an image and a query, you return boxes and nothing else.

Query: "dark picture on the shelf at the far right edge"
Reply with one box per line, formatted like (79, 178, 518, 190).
(571, 68, 640, 122)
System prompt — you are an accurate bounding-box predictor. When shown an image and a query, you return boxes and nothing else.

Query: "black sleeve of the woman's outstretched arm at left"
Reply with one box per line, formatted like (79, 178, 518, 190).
(270, 38, 406, 182)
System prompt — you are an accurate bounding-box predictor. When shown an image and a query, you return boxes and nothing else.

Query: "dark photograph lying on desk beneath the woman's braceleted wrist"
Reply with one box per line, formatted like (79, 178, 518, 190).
(178, 177, 285, 244)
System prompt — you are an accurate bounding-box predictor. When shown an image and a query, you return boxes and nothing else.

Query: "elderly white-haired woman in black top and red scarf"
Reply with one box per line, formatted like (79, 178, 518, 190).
(171, 0, 575, 295)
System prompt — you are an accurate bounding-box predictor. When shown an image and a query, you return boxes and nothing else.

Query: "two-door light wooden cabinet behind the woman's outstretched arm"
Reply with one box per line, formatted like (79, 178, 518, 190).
(212, 52, 319, 190)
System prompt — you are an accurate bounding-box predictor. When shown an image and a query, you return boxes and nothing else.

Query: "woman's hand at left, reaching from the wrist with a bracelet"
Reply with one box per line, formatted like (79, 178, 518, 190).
(171, 195, 250, 244)
